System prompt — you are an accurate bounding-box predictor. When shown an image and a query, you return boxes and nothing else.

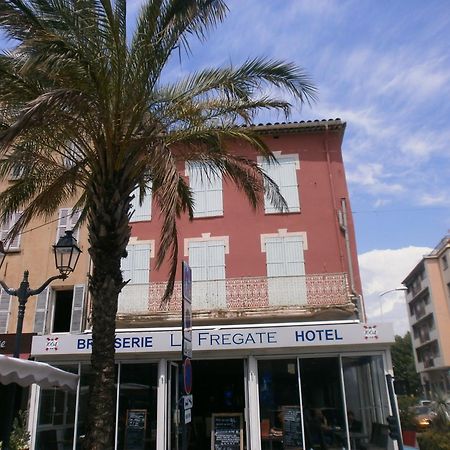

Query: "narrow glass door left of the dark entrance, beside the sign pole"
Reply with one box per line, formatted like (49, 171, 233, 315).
(167, 362, 181, 450)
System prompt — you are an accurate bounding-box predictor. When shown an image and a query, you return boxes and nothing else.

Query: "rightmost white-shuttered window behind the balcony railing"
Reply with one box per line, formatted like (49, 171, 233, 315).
(263, 233, 306, 305)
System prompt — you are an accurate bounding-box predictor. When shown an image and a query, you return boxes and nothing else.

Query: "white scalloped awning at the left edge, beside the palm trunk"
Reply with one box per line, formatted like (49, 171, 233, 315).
(0, 355, 78, 390)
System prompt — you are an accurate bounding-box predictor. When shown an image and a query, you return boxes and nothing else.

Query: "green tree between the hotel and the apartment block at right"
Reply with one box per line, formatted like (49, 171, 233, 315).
(391, 331, 421, 395)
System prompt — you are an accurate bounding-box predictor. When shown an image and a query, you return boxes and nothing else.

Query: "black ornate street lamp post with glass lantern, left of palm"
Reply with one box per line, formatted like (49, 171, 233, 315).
(0, 230, 81, 450)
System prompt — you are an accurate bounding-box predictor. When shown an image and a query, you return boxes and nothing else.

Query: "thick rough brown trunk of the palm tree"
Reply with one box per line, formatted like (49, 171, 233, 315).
(83, 180, 130, 450)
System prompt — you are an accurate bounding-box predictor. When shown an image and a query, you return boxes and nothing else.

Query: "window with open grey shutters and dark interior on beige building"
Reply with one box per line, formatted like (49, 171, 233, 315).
(33, 285, 85, 334)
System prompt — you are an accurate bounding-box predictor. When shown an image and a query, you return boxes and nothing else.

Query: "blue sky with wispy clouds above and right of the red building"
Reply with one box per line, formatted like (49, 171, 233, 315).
(0, 0, 450, 333)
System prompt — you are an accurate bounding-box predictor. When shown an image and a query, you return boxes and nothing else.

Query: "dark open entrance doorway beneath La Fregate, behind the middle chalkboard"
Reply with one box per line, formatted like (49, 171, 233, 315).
(169, 359, 246, 450)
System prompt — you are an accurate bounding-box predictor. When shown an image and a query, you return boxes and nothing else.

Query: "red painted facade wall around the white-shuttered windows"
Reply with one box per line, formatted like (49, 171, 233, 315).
(132, 121, 361, 294)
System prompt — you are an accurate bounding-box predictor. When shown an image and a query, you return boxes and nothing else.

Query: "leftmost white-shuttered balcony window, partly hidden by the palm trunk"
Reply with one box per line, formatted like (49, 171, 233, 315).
(118, 243, 152, 314)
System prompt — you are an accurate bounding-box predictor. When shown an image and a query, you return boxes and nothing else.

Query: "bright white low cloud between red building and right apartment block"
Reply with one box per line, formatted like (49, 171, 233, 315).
(358, 246, 432, 335)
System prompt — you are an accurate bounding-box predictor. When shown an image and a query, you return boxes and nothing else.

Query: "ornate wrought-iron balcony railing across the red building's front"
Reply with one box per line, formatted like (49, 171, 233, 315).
(118, 273, 351, 314)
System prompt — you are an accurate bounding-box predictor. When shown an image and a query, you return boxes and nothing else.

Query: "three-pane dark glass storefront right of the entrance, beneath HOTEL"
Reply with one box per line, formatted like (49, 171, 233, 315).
(258, 355, 392, 450)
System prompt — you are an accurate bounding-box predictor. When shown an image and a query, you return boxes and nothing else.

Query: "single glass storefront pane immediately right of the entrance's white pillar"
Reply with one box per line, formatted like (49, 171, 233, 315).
(258, 359, 303, 450)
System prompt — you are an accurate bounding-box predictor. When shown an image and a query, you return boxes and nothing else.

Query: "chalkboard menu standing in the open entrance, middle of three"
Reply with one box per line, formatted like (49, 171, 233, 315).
(211, 413, 244, 450)
